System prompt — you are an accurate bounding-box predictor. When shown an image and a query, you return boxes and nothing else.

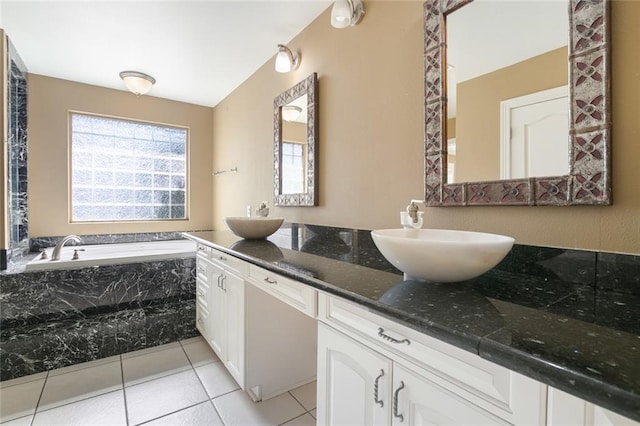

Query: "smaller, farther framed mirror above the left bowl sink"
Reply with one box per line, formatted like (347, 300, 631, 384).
(273, 73, 318, 207)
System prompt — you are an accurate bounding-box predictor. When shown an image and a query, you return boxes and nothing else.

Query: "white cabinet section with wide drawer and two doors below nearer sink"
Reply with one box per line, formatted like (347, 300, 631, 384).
(317, 295, 546, 425)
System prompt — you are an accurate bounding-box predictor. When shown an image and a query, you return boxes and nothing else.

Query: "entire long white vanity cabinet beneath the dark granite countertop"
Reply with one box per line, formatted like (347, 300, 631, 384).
(191, 238, 640, 426)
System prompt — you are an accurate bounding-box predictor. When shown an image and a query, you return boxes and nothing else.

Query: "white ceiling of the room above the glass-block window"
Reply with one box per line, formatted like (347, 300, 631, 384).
(0, 0, 332, 106)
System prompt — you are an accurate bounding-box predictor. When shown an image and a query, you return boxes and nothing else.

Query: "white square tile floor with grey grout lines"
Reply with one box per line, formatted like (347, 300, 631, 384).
(0, 337, 316, 426)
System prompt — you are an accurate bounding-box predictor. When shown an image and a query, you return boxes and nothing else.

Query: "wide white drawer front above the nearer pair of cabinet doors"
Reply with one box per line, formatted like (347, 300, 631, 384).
(318, 293, 546, 424)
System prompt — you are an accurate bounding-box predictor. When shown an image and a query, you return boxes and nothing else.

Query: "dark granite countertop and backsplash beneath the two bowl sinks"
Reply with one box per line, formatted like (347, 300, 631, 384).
(185, 223, 640, 421)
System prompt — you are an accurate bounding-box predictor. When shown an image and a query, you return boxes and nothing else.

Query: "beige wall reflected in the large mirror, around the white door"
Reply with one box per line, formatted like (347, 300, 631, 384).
(456, 46, 569, 182)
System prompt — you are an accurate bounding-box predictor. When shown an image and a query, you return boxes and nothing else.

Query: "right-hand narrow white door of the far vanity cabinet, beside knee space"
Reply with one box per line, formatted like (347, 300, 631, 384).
(221, 271, 245, 389)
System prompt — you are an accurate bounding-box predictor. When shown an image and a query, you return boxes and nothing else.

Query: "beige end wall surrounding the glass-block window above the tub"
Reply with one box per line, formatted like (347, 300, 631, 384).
(28, 74, 213, 237)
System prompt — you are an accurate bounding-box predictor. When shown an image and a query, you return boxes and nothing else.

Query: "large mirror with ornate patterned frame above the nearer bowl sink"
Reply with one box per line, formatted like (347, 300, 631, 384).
(424, 0, 611, 206)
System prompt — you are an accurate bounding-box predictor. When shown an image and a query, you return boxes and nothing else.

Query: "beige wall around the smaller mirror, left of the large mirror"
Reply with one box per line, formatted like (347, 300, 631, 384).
(213, 1, 424, 228)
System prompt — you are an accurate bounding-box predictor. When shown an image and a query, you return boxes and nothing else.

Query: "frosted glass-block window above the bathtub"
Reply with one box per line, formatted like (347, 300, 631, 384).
(71, 113, 188, 222)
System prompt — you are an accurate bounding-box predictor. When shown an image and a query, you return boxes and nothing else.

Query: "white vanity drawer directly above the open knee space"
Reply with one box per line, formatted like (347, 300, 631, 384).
(249, 265, 318, 318)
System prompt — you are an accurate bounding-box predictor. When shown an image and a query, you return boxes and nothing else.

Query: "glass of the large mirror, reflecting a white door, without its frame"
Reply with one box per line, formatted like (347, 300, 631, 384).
(446, 0, 569, 183)
